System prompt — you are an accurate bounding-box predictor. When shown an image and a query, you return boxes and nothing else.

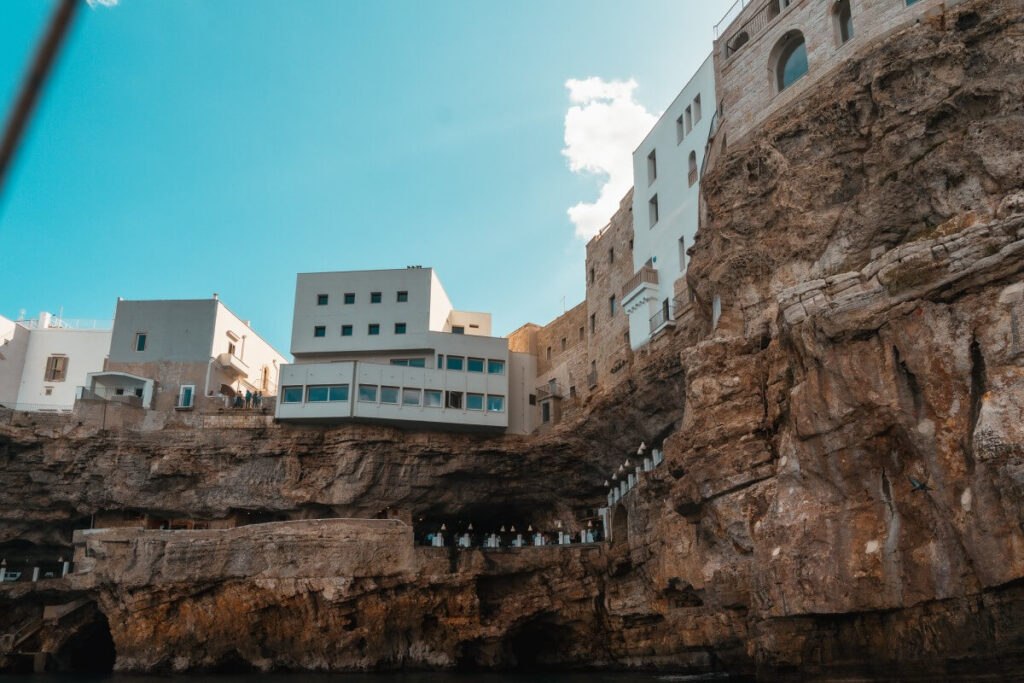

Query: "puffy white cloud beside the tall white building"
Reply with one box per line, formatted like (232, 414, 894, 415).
(562, 77, 657, 240)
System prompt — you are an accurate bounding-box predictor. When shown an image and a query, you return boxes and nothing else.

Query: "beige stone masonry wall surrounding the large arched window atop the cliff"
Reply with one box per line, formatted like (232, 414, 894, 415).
(715, 0, 961, 143)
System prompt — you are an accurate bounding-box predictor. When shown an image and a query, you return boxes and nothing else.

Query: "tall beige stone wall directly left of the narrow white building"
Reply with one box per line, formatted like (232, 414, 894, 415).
(585, 189, 633, 386)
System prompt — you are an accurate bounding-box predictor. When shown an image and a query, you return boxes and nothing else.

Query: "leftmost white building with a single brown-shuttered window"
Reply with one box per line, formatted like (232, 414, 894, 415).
(0, 313, 111, 412)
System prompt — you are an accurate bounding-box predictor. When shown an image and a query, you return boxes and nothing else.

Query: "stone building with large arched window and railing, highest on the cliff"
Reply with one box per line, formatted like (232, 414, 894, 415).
(714, 0, 958, 142)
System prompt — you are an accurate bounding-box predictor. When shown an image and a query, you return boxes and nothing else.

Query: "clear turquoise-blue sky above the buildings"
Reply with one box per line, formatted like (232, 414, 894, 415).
(0, 0, 730, 352)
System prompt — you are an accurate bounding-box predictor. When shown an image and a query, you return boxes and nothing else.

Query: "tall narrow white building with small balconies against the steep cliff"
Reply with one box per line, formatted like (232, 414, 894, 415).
(622, 56, 716, 349)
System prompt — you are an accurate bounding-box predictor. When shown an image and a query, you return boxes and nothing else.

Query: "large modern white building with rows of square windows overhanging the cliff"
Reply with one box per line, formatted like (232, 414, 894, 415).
(276, 267, 536, 432)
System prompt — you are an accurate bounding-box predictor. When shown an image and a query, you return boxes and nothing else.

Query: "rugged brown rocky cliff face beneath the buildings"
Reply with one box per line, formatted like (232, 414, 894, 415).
(0, 0, 1024, 678)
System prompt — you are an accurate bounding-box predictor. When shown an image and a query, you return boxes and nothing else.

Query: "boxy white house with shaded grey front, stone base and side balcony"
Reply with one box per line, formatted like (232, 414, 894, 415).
(82, 295, 288, 410)
